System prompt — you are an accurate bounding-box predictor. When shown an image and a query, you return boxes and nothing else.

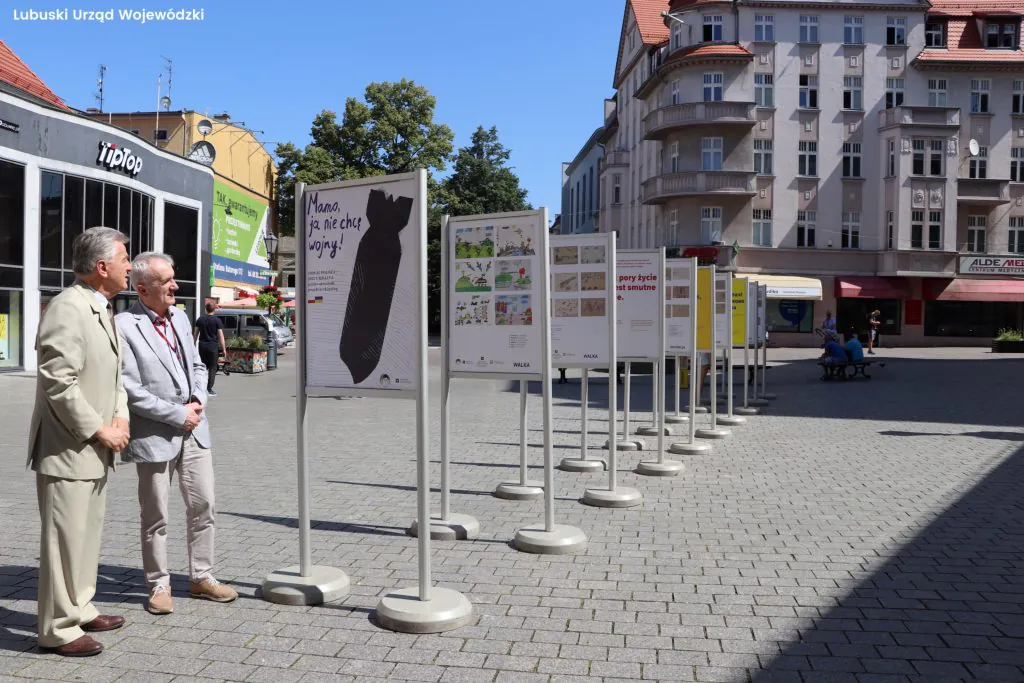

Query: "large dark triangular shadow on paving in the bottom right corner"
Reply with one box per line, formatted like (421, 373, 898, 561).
(754, 440, 1024, 683)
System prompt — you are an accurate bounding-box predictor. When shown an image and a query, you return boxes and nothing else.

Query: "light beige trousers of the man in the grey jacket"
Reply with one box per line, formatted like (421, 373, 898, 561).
(136, 434, 214, 590)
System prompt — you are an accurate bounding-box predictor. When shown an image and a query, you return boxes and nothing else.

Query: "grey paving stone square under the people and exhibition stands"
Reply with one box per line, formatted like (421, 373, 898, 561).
(0, 349, 1024, 683)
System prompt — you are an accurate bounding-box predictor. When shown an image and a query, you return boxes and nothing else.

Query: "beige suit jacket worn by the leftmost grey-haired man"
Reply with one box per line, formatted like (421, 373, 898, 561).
(29, 283, 128, 479)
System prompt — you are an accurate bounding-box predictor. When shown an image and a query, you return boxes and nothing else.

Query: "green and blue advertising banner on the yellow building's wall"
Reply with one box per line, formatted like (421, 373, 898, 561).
(210, 180, 270, 287)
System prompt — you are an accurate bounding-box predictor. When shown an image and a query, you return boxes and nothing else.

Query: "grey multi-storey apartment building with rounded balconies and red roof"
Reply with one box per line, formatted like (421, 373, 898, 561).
(600, 0, 1024, 344)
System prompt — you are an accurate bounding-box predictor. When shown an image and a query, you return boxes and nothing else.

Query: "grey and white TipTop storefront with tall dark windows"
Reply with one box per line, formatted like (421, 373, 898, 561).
(0, 92, 213, 372)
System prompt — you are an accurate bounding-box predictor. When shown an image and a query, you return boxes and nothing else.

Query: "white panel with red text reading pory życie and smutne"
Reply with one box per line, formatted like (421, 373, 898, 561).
(615, 249, 665, 360)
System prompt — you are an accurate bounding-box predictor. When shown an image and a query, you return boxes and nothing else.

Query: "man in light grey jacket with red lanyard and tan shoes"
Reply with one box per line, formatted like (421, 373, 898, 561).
(115, 252, 238, 614)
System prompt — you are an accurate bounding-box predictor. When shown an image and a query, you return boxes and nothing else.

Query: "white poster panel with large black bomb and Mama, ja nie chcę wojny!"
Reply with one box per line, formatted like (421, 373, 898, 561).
(299, 174, 426, 393)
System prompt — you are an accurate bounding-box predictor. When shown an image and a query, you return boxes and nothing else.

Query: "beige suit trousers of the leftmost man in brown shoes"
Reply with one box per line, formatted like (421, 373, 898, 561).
(36, 474, 106, 647)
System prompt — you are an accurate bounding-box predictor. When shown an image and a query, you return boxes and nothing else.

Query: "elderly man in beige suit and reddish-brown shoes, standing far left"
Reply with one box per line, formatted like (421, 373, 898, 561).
(29, 227, 131, 656)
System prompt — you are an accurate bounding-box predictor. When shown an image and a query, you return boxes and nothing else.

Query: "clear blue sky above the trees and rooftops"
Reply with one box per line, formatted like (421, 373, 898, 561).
(0, 0, 625, 218)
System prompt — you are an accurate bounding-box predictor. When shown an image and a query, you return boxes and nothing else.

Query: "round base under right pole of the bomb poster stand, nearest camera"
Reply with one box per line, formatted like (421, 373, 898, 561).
(377, 586, 473, 633)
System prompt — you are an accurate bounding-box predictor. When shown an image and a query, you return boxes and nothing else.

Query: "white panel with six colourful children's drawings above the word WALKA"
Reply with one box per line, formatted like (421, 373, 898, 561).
(442, 211, 548, 375)
